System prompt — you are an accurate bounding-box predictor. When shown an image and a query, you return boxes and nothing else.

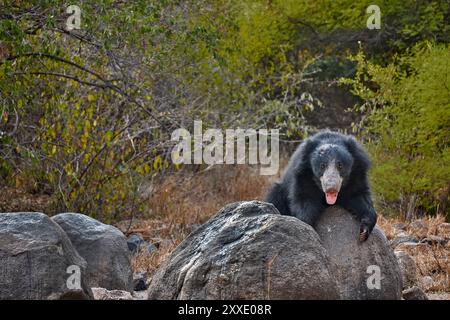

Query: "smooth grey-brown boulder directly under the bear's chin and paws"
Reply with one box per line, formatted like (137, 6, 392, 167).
(316, 206, 402, 300)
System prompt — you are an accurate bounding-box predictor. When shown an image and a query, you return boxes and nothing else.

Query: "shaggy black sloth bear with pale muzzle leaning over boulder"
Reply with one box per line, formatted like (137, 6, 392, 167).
(266, 131, 377, 241)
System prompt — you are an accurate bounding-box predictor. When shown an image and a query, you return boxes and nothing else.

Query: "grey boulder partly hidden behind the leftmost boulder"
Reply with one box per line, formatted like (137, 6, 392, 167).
(52, 213, 133, 292)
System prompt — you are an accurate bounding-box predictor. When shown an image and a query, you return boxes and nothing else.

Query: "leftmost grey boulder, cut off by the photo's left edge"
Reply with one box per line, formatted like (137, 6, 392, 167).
(0, 212, 93, 300)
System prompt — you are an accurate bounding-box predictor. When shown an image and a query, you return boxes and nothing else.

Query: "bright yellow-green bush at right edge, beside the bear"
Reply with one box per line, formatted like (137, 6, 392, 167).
(343, 43, 450, 212)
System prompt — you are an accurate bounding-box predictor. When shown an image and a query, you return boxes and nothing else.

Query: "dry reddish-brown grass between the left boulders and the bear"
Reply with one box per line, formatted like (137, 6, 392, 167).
(125, 166, 276, 275)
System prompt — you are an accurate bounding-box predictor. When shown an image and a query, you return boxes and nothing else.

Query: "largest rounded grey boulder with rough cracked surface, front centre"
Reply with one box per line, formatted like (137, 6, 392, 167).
(148, 201, 339, 299)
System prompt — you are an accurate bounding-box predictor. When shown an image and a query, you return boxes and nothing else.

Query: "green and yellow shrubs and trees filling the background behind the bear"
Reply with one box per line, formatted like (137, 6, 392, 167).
(0, 0, 450, 222)
